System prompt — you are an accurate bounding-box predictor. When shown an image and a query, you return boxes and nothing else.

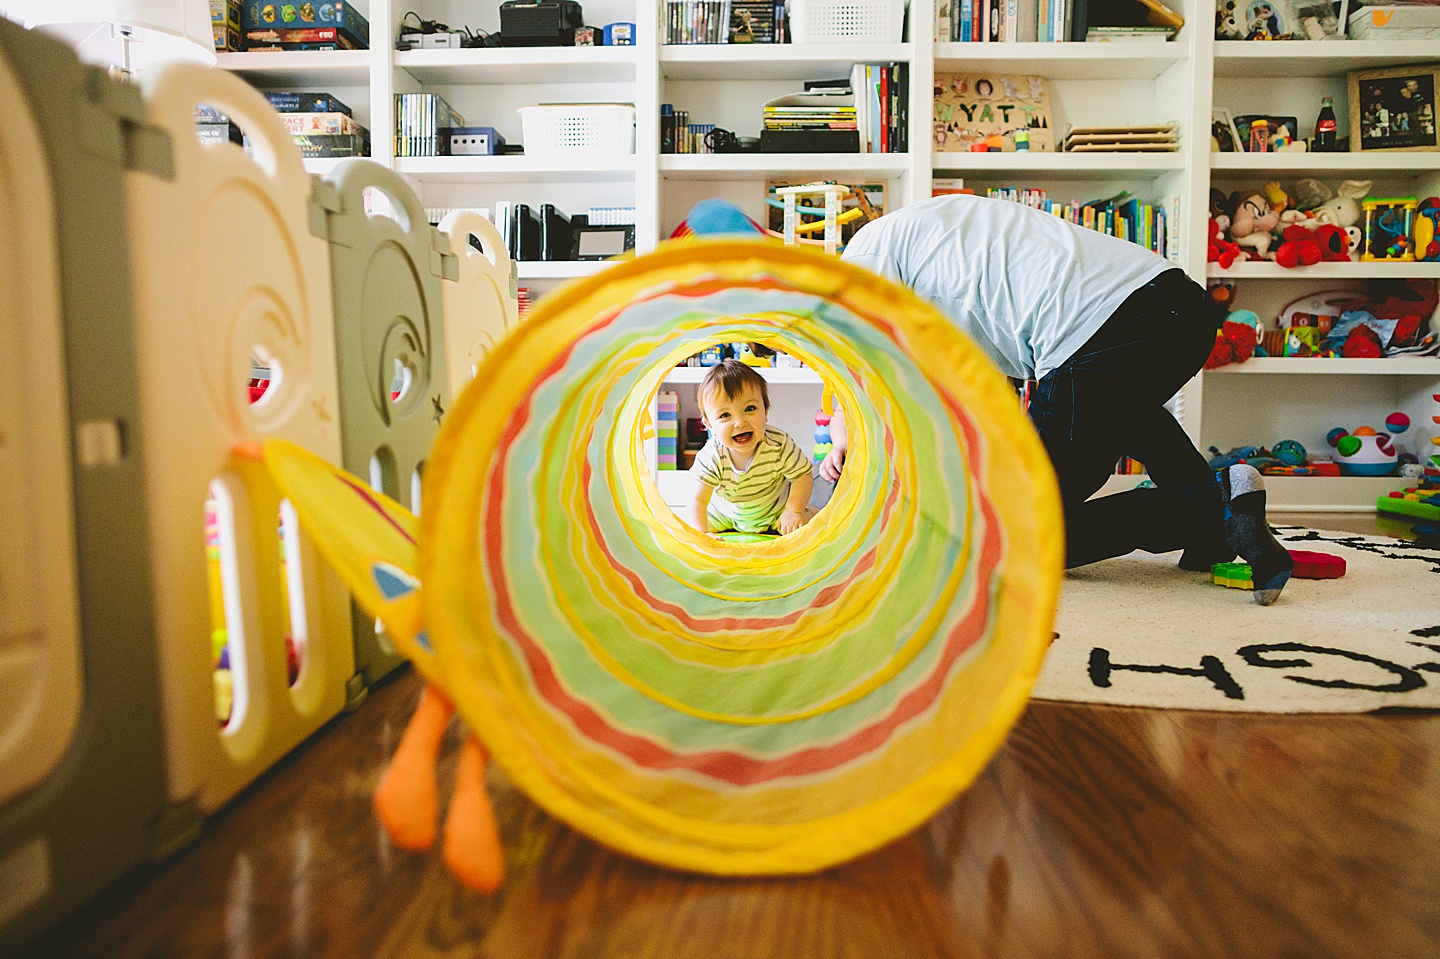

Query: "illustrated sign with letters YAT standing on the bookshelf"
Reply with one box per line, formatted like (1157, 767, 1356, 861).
(935, 73, 1056, 153)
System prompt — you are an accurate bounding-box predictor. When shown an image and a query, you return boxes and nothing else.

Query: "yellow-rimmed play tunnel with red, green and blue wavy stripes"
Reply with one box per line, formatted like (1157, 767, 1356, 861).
(419, 240, 1063, 874)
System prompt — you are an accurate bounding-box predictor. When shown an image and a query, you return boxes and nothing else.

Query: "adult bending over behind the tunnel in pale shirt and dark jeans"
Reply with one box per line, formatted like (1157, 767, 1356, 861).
(821, 194, 1293, 606)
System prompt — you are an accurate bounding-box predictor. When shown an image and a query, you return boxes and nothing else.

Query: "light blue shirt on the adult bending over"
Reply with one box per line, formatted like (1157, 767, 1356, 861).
(842, 193, 1175, 379)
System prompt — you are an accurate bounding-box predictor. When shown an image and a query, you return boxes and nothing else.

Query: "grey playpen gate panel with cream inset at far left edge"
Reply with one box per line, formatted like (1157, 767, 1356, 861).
(0, 20, 172, 945)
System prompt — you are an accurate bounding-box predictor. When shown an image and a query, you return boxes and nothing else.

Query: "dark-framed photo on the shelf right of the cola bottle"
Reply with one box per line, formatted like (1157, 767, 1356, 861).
(1349, 63, 1440, 153)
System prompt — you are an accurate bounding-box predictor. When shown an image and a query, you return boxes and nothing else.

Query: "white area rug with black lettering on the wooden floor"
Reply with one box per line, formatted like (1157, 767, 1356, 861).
(1032, 527, 1440, 713)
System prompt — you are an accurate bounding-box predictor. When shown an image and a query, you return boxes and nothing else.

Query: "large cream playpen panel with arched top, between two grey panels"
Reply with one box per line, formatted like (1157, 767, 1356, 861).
(127, 65, 354, 811)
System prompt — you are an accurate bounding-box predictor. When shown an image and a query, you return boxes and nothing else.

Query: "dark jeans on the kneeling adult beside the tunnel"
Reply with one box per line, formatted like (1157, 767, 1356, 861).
(1030, 269, 1233, 567)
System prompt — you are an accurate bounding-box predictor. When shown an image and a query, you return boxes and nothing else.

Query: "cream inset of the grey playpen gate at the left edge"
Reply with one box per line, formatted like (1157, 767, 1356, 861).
(0, 22, 84, 803)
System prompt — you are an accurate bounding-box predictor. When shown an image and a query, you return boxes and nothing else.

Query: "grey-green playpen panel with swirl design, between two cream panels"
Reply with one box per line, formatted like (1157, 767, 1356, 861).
(317, 160, 458, 684)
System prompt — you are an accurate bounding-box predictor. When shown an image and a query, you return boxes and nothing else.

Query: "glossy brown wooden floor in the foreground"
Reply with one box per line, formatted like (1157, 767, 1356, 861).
(25, 515, 1440, 959)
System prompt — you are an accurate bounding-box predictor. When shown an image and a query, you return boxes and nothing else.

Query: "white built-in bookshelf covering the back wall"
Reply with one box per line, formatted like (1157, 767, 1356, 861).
(220, 0, 1440, 508)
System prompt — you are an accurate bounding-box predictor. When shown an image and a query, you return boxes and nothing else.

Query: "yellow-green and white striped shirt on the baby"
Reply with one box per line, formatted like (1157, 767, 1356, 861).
(690, 426, 811, 533)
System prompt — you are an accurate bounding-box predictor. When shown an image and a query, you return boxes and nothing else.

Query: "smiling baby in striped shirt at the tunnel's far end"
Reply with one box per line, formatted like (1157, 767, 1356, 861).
(690, 360, 814, 533)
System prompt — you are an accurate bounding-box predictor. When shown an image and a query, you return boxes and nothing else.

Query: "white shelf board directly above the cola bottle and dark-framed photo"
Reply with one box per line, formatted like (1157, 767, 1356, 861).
(1214, 40, 1440, 79)
